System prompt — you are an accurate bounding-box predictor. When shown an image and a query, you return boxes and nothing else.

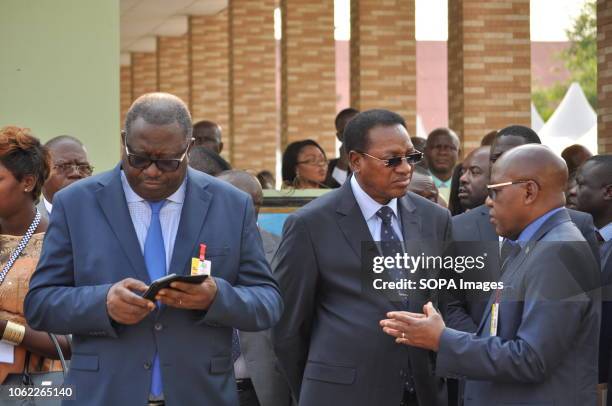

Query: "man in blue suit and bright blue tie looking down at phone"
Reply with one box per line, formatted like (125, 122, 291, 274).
(24, 93, 282, 406)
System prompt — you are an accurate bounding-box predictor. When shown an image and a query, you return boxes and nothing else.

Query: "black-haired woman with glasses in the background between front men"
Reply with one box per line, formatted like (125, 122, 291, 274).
(282, 140, 327, 189)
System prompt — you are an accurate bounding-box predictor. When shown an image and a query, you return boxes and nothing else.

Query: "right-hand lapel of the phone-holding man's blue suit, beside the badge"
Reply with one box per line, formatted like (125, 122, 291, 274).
(168, 169, 212, 275)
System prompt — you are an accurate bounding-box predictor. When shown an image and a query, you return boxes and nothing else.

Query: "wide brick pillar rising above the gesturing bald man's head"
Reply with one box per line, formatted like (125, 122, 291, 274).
(448, 0, 531, 154)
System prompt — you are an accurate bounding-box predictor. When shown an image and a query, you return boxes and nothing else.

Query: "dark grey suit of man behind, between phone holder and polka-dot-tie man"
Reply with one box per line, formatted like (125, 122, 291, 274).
(238, 228, 291, 406)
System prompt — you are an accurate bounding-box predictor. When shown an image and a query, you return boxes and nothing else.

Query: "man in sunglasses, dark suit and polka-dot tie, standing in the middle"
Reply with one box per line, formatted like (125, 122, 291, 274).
(272, 110, 451, 406)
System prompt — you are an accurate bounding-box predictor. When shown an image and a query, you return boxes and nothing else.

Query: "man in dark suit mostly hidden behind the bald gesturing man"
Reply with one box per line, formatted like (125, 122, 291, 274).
(446, 125, 597, 332)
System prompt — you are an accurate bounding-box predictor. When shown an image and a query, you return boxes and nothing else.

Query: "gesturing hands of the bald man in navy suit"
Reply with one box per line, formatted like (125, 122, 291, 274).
(380, 302, 445, 351)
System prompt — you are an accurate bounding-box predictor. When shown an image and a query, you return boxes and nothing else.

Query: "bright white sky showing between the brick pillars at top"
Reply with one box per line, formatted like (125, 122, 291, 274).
(335, 0, 586, 41)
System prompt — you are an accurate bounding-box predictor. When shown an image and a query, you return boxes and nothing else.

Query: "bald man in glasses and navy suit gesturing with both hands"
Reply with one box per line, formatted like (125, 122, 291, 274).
(381, 145, 601, 406)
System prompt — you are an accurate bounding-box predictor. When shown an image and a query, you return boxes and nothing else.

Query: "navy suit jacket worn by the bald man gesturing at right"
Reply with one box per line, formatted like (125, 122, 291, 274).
(437, 210, 601, 406)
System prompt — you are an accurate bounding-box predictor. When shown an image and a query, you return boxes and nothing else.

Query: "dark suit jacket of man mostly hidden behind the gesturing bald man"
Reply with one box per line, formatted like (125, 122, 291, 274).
(447, 204, 599, 332)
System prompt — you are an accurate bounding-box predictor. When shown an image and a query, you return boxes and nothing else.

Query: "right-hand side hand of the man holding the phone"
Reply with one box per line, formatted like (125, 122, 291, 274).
(155, 276, 217, 310)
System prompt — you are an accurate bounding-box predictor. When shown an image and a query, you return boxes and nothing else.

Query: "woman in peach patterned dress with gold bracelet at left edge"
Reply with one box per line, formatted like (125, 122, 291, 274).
(0, 127, 70, 384)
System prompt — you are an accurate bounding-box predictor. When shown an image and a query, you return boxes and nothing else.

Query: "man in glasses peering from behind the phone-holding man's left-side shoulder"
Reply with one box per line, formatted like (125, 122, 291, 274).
(36, 135, 93, 217)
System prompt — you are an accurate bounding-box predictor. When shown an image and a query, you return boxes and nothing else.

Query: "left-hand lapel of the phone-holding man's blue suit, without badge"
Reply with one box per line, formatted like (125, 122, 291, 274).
(96, 166, 151, 284)
